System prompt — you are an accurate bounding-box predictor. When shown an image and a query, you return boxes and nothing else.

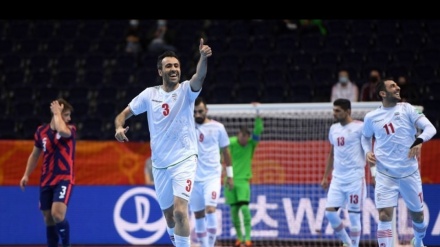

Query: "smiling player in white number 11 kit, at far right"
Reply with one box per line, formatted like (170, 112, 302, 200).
(362, 80, 437, 247)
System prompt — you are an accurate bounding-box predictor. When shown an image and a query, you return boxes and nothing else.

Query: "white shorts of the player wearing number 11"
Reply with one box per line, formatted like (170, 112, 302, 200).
(374, 170, 423, 212)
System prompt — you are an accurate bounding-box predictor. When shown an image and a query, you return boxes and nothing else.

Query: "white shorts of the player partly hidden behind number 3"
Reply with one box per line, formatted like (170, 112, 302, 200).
(189, 177, 221, 212)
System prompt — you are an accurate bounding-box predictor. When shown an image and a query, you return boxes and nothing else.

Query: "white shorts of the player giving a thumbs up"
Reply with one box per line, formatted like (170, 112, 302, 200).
(153, 155, 197, 210)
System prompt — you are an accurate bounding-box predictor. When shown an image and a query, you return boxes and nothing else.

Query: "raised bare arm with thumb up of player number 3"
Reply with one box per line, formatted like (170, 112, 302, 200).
(190, 38, 212, 92)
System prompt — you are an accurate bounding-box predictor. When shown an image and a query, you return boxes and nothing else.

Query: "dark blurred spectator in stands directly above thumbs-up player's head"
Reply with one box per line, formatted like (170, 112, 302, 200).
(148, 19, 177, 54)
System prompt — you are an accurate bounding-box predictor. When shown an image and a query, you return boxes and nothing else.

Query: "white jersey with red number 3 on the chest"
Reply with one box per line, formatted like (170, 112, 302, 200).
(128, 80, 201, 168)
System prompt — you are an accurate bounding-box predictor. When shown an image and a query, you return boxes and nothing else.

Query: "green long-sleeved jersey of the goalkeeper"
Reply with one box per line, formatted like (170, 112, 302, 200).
(229, 117, 264, 180)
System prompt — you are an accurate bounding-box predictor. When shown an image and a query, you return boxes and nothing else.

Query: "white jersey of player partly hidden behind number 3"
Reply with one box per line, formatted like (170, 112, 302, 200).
(195, 120, 229, 181)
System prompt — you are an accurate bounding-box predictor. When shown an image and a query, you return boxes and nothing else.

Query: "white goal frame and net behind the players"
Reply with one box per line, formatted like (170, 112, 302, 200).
(196, 102, 423, 246)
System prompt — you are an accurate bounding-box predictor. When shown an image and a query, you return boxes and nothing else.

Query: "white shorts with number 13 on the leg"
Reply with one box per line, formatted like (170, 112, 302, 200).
(326, 178, 367, 212)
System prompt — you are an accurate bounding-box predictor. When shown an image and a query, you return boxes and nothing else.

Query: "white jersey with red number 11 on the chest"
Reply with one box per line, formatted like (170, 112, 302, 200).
(363, 102, 424, 178)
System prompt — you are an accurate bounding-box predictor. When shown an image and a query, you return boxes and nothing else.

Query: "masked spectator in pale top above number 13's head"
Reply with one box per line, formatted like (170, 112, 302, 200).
(330, 70, 359, 102)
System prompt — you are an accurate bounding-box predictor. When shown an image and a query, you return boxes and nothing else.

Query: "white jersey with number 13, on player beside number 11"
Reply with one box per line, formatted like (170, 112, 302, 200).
(328, 120, 366, 183)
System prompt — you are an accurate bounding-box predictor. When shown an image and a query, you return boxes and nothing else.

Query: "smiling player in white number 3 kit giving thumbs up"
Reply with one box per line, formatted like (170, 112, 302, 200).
(115, 39, 212, 247)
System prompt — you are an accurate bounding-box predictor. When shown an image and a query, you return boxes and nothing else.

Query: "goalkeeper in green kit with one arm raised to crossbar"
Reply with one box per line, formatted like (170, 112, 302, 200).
(224, 103, 264, 247)
